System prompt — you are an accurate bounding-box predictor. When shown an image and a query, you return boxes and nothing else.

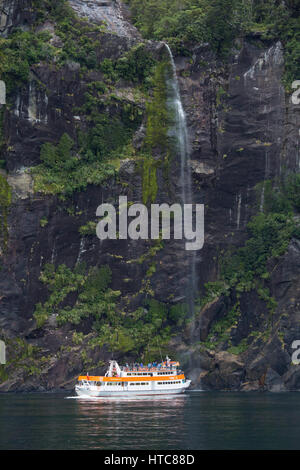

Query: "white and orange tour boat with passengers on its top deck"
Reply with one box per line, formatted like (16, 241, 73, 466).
(75, 357, 191, 397)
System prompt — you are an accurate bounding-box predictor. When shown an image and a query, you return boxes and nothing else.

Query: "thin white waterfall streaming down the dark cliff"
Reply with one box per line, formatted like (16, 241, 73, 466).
(165, 43, 196, 316)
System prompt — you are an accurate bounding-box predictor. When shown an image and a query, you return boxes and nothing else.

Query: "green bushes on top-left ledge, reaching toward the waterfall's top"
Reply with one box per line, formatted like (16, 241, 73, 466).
(0, 0, 154, 95)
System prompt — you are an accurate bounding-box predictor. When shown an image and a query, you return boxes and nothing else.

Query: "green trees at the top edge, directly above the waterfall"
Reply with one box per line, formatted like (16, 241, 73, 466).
(128, 0, 238, 54)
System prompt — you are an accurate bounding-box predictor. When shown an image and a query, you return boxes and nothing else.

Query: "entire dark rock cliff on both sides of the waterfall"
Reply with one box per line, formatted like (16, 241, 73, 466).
(0, 0, 300, 391)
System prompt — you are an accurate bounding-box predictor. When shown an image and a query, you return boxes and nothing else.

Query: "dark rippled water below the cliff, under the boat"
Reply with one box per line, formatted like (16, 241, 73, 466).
(0, 392, 300, 450)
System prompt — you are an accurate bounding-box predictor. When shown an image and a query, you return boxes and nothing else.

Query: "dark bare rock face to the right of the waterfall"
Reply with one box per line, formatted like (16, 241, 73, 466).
(173, 36, 300, 391)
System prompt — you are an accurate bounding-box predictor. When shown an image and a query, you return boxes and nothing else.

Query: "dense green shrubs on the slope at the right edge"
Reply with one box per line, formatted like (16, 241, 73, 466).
(207, 174, 300, 300)
